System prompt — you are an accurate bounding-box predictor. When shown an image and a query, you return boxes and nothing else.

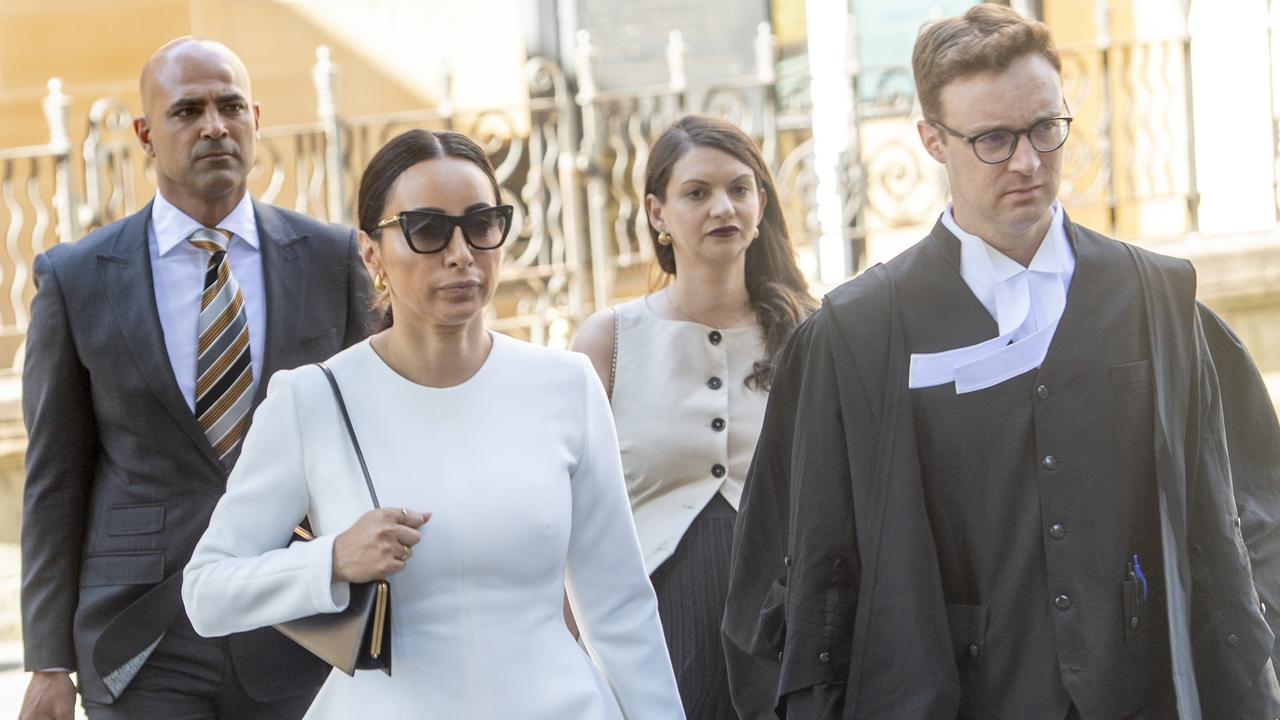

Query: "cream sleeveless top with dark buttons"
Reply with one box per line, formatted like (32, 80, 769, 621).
(612, 299, 768, 574)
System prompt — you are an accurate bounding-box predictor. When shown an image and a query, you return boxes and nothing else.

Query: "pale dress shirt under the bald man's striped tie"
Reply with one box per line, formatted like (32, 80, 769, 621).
(147, 191, 266, 413)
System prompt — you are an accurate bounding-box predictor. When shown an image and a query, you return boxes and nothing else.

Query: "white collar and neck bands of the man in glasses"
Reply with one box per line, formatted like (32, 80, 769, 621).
(909, 201, 1075, 393)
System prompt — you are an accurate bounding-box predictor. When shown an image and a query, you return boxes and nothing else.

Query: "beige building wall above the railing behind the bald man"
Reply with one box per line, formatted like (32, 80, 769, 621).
(0, 0, 525, 147)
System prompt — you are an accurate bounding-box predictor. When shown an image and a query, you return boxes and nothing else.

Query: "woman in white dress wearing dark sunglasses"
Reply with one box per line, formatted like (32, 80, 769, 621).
(183, 131, 684, 720)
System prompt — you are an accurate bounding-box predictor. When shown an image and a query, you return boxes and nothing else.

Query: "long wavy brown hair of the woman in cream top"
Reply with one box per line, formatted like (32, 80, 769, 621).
(644, 115, 817, 391)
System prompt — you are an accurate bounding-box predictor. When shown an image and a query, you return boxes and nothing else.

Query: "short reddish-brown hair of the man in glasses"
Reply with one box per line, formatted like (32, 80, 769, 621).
(911, 3, 1062, 120)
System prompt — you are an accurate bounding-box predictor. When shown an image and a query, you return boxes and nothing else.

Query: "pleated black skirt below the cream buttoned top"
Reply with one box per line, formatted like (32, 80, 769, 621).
(650, 493, 737, 720)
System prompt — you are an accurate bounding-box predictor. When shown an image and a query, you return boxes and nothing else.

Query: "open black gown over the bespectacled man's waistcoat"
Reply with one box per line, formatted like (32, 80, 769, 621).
(723, 220, 1280, 720)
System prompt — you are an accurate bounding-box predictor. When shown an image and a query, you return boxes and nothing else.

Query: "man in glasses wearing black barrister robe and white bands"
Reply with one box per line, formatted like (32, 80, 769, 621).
(723, 5, 1280, 720)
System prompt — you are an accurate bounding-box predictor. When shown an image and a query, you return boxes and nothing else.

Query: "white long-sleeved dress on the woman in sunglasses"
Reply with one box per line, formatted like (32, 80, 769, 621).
(182, 333, 684, 720)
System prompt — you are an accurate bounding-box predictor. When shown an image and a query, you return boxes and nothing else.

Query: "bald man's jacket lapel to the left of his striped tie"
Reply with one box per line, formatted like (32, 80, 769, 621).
(99, 204, 223, 471)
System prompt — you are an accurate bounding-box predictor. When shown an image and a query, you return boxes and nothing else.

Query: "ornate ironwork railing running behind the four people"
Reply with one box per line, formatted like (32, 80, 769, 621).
(0, 0, 1223, 358)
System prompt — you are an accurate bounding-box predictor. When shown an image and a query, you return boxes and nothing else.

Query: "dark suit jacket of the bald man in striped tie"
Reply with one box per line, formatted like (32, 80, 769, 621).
(22, 202, 370, 702)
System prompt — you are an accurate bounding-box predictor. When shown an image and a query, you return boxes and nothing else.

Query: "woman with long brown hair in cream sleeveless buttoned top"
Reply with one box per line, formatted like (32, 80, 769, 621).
(575, 117, 813, 720)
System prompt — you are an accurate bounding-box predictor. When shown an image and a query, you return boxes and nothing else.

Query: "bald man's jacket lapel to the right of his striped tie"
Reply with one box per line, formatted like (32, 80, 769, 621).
(253, 201, 307, 405)
